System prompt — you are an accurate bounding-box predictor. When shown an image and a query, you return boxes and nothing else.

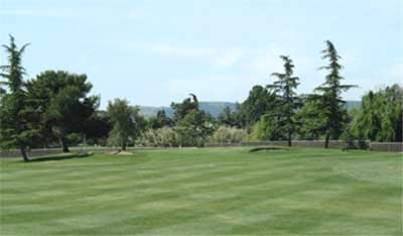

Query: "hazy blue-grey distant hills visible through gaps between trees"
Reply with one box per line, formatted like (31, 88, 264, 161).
(139, 101, 361, 117)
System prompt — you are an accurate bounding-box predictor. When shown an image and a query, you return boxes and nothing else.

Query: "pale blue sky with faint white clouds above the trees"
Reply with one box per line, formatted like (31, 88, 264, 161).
(0, 0, 403, 108)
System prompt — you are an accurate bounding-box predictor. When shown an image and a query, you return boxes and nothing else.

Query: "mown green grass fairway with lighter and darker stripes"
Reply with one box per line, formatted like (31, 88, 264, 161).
(0, 148, 402, 235)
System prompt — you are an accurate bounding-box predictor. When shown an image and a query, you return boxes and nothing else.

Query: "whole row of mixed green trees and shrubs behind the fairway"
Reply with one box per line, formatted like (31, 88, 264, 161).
(0, 36, 403, 161)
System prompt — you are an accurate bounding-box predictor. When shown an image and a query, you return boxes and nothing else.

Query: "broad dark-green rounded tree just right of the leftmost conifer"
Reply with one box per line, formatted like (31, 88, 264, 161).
(27, 71, 99, 152)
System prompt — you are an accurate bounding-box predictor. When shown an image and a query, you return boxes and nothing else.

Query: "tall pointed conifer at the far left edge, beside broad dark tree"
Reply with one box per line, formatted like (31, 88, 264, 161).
(0, 35, 36, 161)
